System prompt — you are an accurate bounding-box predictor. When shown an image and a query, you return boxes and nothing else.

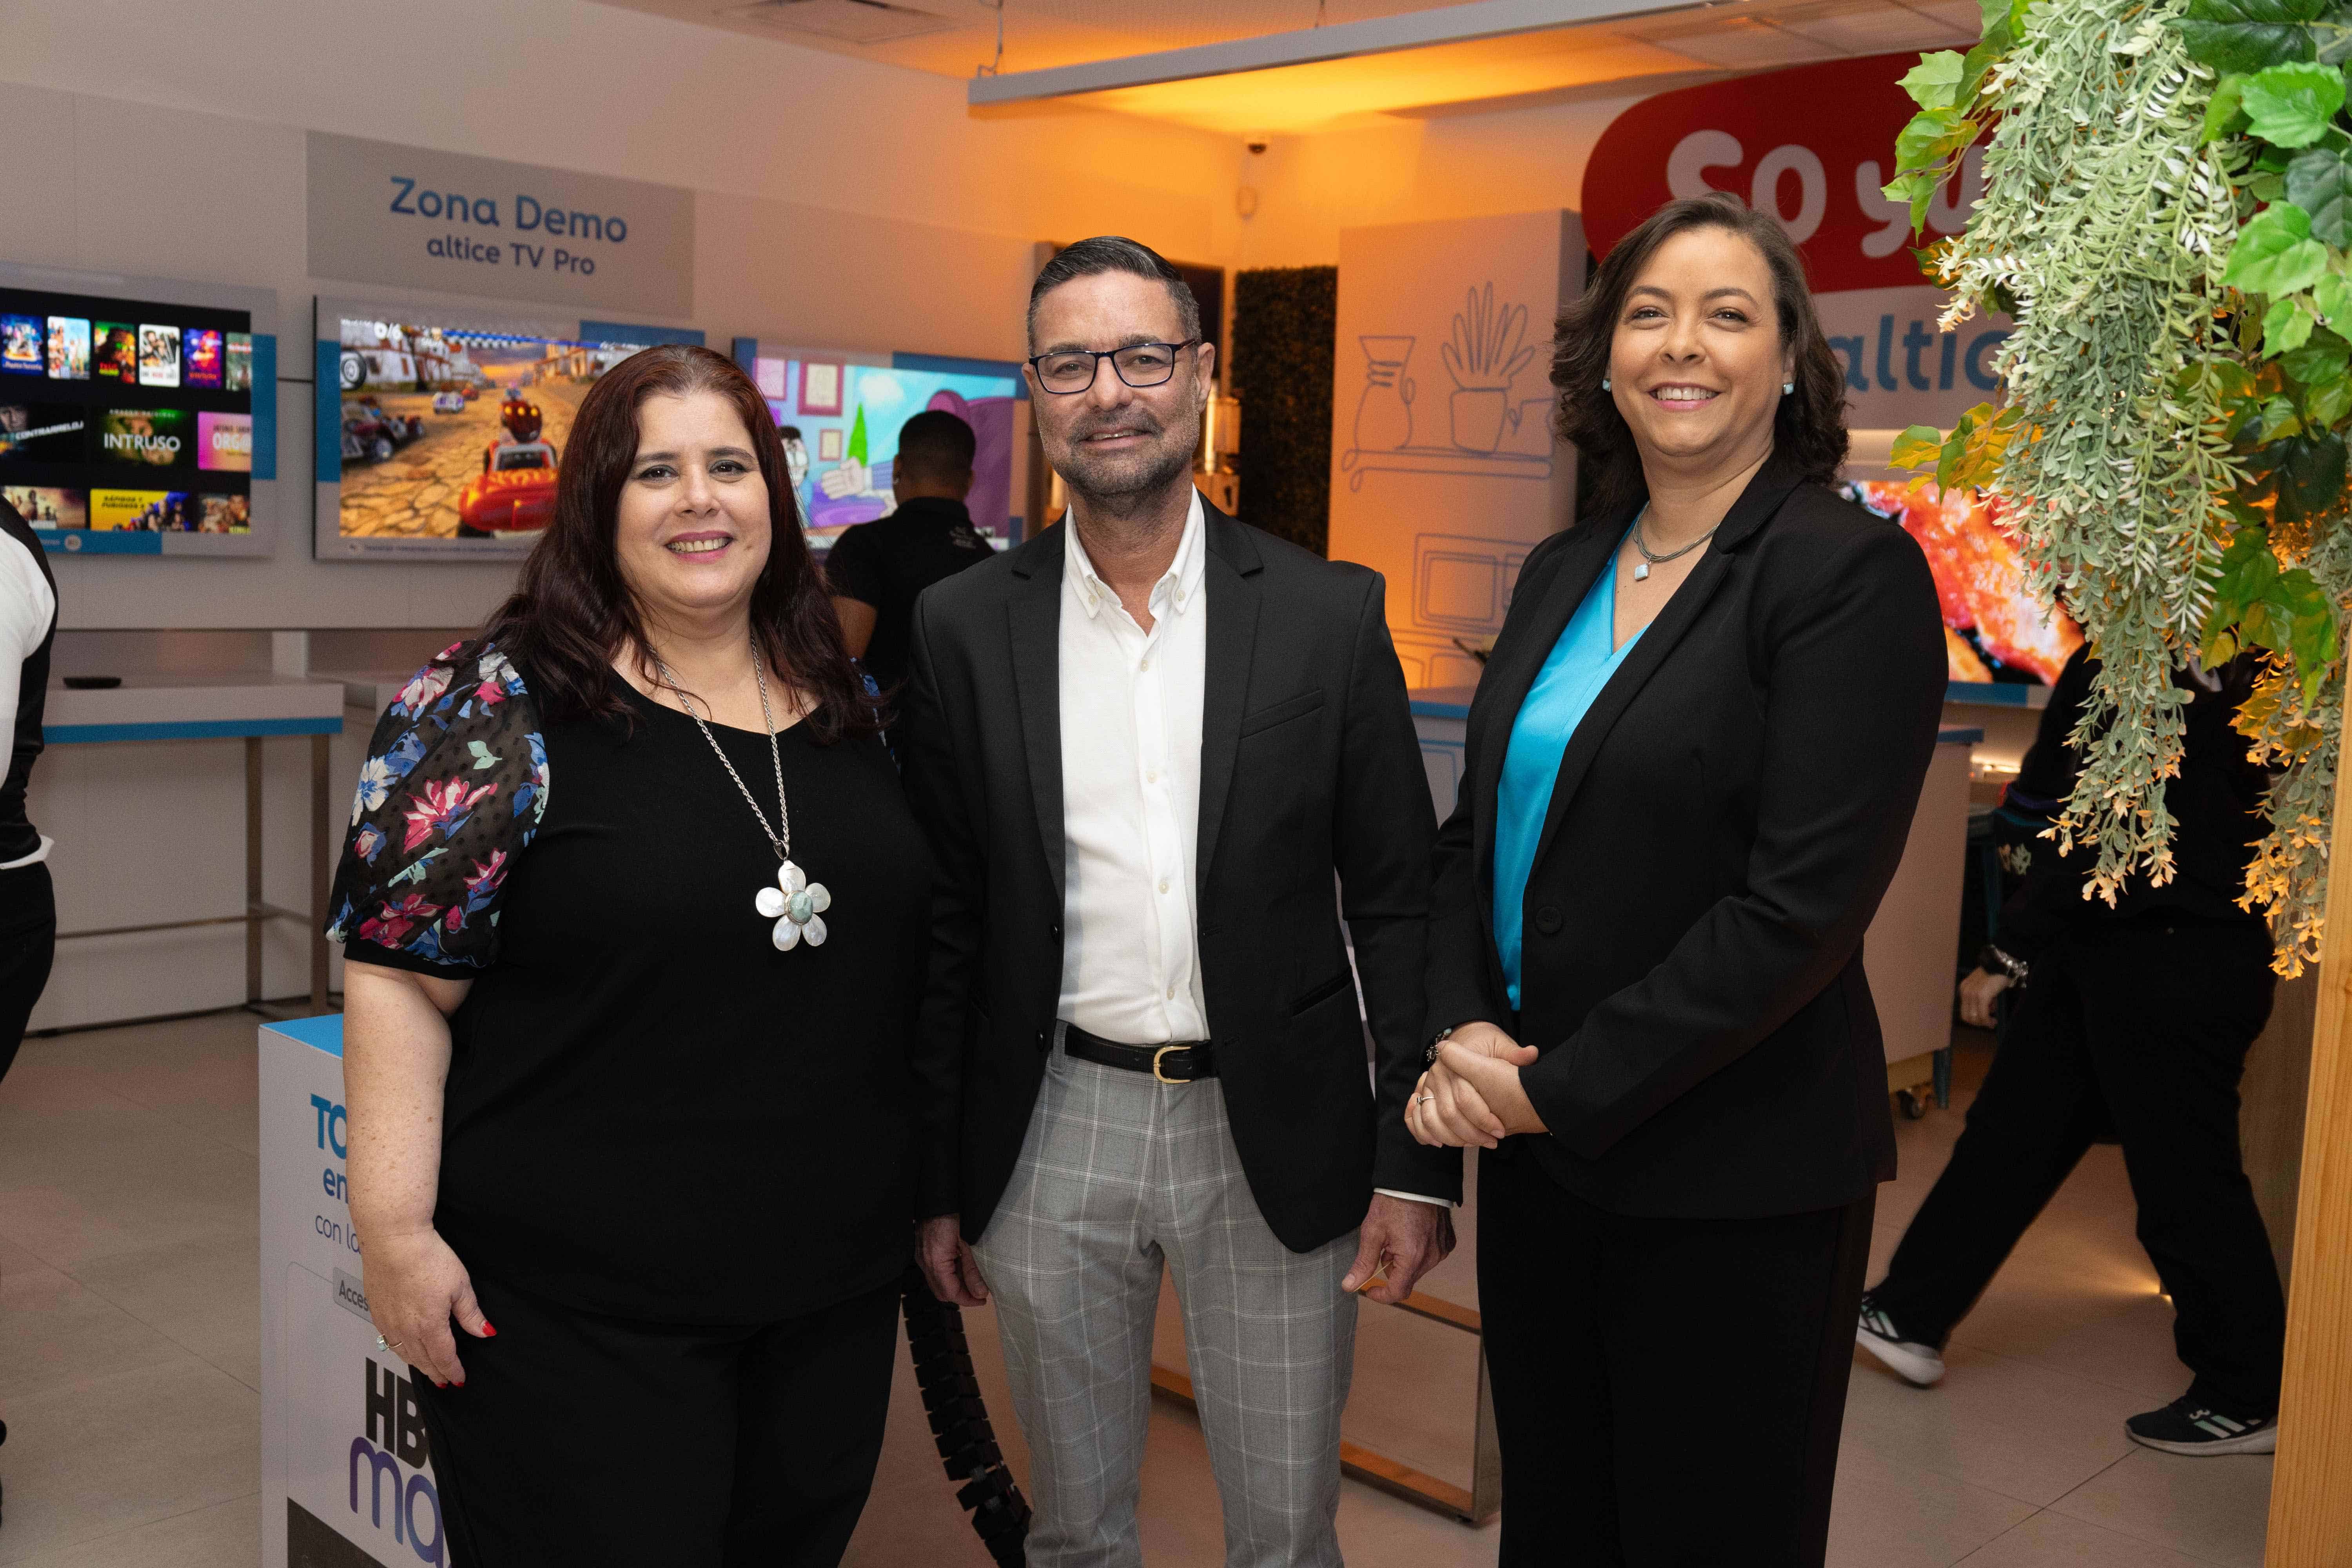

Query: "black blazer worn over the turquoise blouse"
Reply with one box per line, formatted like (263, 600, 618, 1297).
(1428, 463, 1945, 1218)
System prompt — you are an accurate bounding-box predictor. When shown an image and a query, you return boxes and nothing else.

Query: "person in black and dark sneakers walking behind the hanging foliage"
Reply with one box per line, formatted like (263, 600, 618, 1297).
(1853, 644, 2286, 1455)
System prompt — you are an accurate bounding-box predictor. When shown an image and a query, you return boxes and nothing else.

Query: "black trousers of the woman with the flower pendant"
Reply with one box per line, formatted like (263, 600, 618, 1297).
(412, 1274, 898, 1568)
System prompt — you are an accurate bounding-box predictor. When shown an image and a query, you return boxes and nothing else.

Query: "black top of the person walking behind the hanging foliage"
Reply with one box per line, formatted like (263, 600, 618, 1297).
(1994, 644, 2272, 959)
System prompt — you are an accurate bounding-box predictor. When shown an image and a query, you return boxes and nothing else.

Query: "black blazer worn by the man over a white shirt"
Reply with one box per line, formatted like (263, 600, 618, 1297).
(901, 505, 1463, 1253)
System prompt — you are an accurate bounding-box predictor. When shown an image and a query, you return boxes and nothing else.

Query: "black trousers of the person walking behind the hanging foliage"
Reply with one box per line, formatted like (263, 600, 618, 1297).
(1872, 917, 2286, 1415)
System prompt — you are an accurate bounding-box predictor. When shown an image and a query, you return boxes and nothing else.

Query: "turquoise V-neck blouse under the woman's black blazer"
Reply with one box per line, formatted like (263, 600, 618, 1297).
(1494, 555, 1642, 1009)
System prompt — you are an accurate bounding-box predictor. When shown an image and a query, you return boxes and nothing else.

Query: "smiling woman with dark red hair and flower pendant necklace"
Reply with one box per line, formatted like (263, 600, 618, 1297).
(329, 348, 931, 1568)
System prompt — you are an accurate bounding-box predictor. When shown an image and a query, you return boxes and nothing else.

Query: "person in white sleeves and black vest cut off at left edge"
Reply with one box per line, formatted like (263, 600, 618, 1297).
(0, 501, 56, 1077)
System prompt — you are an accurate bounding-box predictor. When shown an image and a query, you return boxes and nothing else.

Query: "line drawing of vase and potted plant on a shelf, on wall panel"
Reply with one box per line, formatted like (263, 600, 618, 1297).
(1338, 282, 1552, 491)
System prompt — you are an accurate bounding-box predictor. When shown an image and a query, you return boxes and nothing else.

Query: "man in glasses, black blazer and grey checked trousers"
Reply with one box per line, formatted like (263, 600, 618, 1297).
(901, 240, 1461, 1568)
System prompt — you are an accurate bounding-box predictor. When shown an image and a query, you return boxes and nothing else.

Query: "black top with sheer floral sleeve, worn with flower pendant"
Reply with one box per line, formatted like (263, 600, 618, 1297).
(332, 653, 931, 1323)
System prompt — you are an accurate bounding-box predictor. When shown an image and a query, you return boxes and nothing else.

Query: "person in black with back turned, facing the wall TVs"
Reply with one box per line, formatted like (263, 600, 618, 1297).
(826, 409, 993, 691)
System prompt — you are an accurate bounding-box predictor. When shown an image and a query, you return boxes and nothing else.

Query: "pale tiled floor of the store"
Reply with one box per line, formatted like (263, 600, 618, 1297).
(0, 1013, 2270, 1568)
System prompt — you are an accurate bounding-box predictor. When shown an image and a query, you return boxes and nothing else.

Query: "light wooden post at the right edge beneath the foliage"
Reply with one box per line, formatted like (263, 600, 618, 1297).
(2263, 738, 2352, 1568)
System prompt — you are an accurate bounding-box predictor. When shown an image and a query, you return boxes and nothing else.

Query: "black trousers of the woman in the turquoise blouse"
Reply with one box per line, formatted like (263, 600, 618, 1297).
(1477, 1145, 1877, 1568)
